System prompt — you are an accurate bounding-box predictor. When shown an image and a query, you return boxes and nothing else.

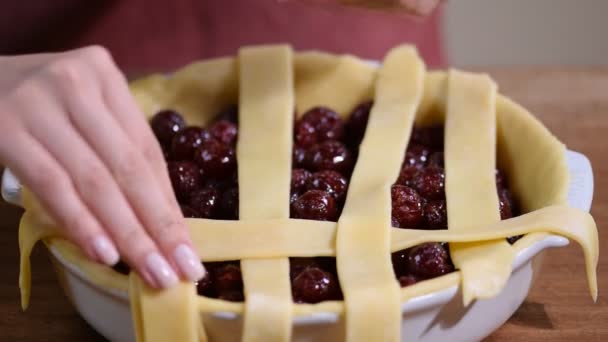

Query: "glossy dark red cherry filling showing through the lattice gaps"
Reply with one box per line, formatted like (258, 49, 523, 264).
(114, 102, 520, 303)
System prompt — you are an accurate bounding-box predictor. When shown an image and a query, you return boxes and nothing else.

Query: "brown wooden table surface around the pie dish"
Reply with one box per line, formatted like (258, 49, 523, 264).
(0, 69, 608, 342)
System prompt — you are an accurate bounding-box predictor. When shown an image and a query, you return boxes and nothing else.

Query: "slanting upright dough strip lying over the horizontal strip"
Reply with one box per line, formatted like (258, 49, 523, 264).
(336, 46, 425, 342)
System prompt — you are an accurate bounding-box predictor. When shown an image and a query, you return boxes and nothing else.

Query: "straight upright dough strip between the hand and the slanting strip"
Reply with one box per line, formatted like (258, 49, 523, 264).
(238, 45, 294, 342)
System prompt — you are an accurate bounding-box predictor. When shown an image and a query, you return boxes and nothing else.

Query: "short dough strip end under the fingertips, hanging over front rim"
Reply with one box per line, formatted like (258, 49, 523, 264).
(129, 272, 202, 342)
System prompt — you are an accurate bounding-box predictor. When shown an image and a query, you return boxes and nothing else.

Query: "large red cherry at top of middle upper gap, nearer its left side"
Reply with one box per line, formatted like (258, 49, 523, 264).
(296, 107, 344, 143)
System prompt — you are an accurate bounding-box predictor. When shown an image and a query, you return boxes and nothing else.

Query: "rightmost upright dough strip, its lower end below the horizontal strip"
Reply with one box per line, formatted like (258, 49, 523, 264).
(445, 70, 515, 306)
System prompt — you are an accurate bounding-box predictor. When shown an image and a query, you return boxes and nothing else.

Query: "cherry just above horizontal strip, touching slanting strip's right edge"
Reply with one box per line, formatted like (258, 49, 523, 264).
(391, 185, 423, 228)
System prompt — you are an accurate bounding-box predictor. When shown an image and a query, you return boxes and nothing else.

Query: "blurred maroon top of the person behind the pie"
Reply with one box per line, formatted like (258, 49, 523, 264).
(0, 0, 445, 71)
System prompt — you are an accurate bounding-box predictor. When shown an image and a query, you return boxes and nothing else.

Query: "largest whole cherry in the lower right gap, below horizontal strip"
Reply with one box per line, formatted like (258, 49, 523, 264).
(408, 242, 454, 279)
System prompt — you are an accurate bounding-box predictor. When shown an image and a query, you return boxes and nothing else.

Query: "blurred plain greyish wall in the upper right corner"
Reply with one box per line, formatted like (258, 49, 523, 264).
(443, 0, 608, 66)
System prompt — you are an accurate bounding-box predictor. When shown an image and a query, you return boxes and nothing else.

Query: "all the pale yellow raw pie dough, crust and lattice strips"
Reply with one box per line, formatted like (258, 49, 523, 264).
(14, 46, 599, 342)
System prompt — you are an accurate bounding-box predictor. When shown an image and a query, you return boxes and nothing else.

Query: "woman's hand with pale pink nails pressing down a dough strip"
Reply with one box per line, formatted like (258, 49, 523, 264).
(0, 46, 205, 288)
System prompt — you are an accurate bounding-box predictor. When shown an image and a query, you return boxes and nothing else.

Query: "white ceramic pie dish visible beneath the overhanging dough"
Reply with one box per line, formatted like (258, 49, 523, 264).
(2, 151, 593, 342)
